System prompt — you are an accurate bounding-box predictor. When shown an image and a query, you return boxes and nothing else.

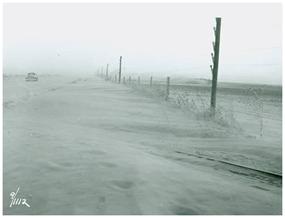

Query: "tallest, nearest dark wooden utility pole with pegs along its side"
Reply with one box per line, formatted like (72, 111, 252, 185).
(210, 17, 221, 114)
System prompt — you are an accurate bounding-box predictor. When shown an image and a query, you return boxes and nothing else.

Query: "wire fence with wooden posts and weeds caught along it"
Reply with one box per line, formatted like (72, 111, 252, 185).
(100, 73, 282, 137)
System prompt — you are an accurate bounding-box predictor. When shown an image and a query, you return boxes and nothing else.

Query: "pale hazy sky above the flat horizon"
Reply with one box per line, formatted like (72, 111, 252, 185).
(3, 3, 282, 84)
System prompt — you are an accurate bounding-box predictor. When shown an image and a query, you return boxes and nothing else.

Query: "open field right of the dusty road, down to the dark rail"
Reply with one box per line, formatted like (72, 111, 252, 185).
(123, 78, 282, 175)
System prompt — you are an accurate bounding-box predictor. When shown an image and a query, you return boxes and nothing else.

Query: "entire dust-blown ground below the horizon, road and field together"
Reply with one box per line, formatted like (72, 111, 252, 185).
(3, 76, 282, 214)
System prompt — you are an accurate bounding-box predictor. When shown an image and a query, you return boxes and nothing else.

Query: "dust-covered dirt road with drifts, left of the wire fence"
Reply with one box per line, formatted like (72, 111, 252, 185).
(3, 78, 282, 215)
